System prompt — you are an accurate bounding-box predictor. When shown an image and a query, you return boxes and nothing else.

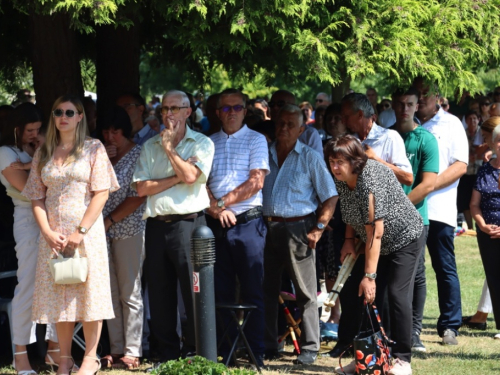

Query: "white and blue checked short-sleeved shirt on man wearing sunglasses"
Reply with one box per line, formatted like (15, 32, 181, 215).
(208, 125, 269, 215)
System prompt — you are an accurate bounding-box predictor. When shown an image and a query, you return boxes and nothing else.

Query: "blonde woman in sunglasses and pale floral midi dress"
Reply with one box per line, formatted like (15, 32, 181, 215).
(23, 95, 119, 375)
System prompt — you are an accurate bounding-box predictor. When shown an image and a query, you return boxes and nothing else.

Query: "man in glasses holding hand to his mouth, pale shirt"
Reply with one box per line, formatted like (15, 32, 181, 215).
(132, 90, 214, 368)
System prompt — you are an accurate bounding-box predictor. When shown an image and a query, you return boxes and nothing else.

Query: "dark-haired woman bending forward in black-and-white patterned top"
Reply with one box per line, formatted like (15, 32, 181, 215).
(325, 135, 424, 375)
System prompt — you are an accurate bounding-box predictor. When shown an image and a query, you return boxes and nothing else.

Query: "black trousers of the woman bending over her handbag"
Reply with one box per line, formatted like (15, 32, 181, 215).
(339, 232, 425, 362)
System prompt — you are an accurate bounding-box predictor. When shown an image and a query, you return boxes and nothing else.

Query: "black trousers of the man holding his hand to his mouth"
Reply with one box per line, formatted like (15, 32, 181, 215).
(145, 216, 205, 362)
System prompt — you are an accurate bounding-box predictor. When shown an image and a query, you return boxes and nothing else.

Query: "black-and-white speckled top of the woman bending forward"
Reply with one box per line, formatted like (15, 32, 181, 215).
(334, 160, 423, 255)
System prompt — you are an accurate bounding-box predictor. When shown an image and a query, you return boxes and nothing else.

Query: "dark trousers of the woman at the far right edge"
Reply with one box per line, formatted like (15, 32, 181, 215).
(476, 231, 500, 330)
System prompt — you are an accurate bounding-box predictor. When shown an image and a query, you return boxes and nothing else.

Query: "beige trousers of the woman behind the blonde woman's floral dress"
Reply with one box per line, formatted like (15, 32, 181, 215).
(107, 231, 145, 357)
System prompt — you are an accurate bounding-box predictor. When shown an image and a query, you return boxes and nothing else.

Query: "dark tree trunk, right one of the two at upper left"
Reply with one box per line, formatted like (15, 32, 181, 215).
(96, 21, 140, 113)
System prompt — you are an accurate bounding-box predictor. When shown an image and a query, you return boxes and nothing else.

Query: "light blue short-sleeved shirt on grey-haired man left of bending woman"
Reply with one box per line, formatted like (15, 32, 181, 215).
(262, 141, 338, 218)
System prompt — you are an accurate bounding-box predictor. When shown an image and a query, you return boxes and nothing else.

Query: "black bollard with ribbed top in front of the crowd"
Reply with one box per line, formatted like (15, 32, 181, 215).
(191, 225, 217, 362)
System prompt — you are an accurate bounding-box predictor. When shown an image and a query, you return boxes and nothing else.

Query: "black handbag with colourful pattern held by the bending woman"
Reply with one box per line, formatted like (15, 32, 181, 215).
(339, 301, 394, 375)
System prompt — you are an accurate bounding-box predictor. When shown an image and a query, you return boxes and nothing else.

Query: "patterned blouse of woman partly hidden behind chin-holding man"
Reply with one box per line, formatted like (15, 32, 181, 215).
(102, 145, 146, 240)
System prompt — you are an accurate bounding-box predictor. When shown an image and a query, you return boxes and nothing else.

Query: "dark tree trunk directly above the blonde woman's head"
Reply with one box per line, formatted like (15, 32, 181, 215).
(30, 13, 83, 120)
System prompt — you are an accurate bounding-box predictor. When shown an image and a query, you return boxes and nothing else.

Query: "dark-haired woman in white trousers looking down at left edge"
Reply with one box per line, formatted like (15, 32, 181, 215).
(0, 103, 59, 375)
